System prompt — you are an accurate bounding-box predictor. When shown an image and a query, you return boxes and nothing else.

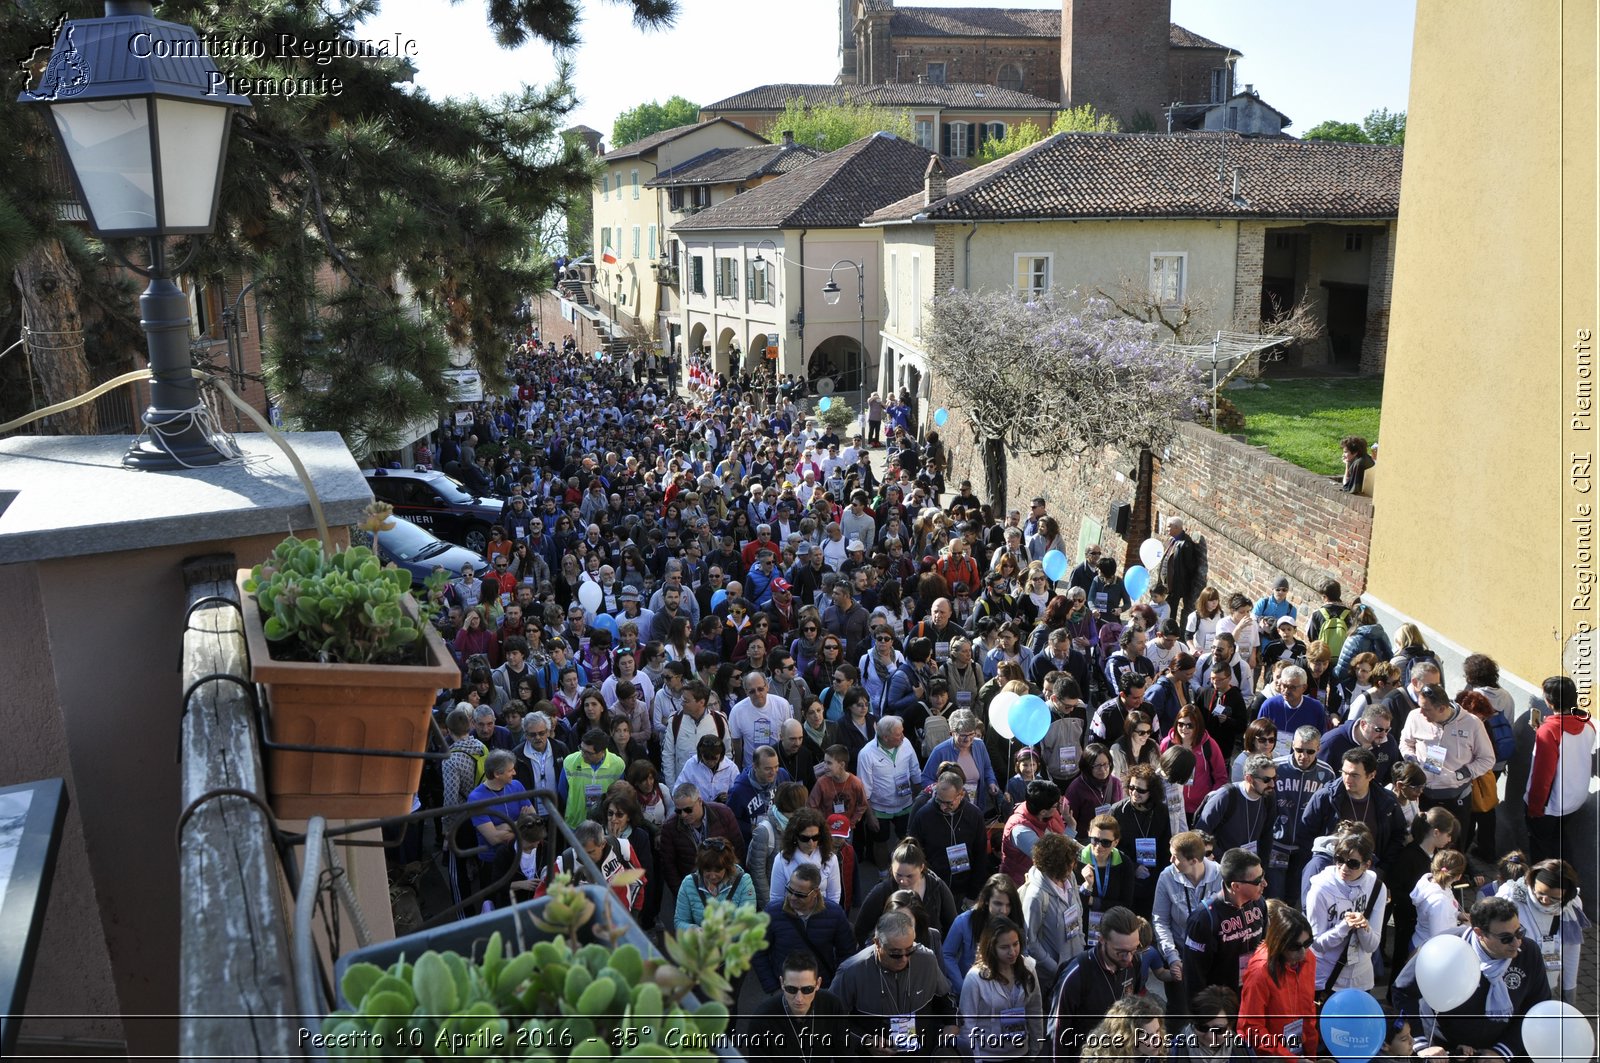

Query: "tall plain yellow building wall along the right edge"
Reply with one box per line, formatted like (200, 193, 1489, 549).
(1368, 0, 1597, 695)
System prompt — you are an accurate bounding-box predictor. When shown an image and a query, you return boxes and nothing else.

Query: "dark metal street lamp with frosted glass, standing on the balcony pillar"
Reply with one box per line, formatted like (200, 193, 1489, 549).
(18, 0, 250, 469)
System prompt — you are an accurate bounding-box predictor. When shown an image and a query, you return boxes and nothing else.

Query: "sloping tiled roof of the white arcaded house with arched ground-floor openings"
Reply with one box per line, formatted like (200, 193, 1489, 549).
(674, 133, 933, 229)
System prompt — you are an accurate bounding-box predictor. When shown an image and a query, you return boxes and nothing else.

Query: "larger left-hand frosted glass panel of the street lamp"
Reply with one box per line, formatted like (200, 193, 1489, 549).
(50, 96, 157, 234)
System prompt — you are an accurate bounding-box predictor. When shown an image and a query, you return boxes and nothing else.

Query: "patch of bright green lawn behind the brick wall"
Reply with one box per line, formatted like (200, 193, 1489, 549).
(1222, 376, 1384, 475)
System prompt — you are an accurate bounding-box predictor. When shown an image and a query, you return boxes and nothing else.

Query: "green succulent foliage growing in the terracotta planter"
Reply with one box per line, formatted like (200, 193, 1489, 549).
(245, 503, 437, 664)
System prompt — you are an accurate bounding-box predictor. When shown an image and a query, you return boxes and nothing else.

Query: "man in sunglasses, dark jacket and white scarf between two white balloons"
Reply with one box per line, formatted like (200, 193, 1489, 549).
(1390, 897, 1550, 1060)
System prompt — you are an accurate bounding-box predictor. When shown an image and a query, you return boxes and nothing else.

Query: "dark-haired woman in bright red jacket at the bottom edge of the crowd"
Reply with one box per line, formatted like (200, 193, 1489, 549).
(1238, 900, 1317, 1060)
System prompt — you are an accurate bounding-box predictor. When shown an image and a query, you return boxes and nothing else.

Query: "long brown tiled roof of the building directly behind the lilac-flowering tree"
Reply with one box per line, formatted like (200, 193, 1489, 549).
(867, 133, 1402, 224)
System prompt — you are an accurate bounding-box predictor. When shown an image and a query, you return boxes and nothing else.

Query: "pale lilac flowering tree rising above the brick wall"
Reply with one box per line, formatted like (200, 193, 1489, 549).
(923, 288, 1205, 521)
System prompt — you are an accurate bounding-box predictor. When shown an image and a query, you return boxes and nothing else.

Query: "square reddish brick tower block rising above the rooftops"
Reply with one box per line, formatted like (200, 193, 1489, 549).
(1061, 0, 1171, 121)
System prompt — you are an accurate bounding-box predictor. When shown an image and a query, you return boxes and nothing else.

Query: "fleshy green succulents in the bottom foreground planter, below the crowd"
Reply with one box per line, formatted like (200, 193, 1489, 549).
(322, 876, 768, 1063)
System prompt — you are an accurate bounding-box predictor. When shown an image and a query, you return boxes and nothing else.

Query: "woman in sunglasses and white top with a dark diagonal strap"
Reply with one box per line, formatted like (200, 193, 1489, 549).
(1306, 834, 1389, 993)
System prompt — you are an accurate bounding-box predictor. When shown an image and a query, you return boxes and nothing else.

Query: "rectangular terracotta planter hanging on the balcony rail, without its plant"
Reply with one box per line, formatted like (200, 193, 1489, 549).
(238, 568, 461, 820)
